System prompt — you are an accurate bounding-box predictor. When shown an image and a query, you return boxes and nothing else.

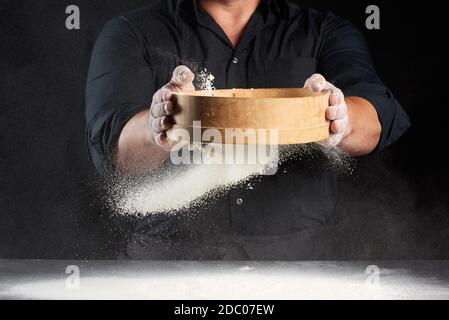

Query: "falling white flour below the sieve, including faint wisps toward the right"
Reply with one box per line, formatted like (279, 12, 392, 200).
(111, 144, 352, 215)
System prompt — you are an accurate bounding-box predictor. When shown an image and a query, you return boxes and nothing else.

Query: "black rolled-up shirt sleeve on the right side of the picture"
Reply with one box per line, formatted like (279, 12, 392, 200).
(318, 14, 410, 150)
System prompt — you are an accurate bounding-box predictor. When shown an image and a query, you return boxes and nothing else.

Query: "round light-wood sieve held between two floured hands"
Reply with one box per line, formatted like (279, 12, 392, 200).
(168, 88, 330, 144)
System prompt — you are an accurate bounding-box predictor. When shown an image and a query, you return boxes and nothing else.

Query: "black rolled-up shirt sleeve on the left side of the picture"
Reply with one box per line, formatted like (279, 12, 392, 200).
(86, 17, 155, 173)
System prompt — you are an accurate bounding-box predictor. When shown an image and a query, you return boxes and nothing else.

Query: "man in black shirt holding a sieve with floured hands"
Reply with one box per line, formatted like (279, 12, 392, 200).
(86, 0, 409, 259)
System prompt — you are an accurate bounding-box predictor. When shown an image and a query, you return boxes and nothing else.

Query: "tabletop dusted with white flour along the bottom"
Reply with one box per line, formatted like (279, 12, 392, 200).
(0, 260, 449, 300)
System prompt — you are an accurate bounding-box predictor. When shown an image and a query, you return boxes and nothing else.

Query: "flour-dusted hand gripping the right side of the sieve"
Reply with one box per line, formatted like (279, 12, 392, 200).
(304, 73, 349, 147)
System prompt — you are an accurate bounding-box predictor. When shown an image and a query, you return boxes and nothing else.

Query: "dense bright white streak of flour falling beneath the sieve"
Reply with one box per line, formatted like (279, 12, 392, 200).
(115, 144, 277, 215)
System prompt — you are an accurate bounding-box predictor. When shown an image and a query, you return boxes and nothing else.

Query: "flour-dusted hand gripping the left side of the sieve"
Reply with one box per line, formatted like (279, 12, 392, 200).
(149, 66, 195, 151)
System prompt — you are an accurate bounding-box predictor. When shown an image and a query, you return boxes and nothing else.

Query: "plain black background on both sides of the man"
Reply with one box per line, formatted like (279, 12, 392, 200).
(0, 0, 449, 259)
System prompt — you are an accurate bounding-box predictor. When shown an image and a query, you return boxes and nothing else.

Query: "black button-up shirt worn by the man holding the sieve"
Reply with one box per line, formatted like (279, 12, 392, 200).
(86, 0, 409, 257)
